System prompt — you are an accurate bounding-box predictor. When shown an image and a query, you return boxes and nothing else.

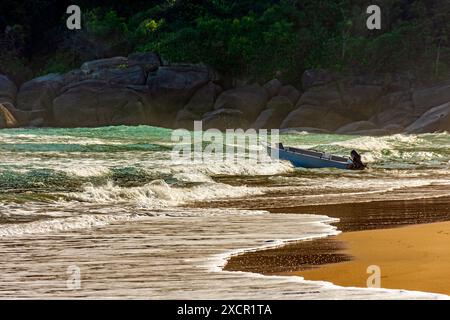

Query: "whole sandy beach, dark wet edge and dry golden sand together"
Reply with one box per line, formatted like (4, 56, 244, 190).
(225, 197, 450, 294)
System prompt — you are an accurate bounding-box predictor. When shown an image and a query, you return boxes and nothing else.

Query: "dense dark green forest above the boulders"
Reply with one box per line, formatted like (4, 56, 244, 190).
(0, 0, 450, 82)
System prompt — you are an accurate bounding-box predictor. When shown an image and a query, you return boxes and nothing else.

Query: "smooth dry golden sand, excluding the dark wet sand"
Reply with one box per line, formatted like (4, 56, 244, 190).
(290, 222, 450, 295)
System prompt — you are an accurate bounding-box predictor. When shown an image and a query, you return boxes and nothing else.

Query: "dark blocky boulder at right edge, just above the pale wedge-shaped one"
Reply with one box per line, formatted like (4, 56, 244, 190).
(412, 84, 450, 115)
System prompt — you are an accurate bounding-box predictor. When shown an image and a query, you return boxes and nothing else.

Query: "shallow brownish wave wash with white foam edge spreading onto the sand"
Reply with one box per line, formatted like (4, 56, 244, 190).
(0, 204, 449, 299)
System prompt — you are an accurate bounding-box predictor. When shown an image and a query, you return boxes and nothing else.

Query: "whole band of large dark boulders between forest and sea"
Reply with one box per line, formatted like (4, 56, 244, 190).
(0, 53, 450, 135)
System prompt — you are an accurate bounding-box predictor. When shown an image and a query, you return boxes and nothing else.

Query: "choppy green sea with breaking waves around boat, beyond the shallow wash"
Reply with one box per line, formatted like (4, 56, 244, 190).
(0, 126, 450, 221)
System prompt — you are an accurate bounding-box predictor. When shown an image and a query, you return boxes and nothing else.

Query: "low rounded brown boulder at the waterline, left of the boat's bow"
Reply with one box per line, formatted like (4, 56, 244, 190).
(202, 109, 249, 131)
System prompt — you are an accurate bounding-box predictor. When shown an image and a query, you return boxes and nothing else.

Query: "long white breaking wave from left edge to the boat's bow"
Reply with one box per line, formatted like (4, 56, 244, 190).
(0, 148, 293, 182)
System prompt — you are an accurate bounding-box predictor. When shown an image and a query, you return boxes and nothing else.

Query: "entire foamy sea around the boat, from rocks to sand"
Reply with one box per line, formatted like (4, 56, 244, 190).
(0, 126, 450, 299)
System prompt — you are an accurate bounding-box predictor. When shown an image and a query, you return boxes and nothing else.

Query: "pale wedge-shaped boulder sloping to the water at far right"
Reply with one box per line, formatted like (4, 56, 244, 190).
(405, 102, 450, 133)
